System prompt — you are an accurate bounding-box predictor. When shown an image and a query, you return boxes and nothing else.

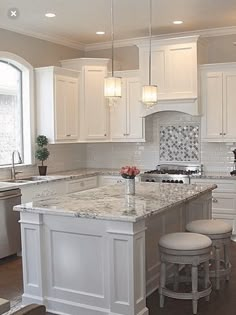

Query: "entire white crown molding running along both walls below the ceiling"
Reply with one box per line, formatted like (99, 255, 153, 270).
(0, 23, 236, 52)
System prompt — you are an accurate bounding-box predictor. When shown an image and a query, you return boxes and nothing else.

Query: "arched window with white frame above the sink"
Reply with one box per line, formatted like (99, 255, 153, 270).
(0, 52, 34, 166)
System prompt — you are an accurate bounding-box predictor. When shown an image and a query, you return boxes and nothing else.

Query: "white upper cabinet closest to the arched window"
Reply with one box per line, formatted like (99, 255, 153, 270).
(35, 67, 79, 143)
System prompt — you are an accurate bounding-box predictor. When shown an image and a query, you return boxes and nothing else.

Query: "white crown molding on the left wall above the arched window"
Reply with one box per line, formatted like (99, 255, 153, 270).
(0, 23, 86, 51)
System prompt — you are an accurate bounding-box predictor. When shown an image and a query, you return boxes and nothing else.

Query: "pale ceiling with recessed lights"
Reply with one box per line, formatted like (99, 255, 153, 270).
(0, 0, 236, 45)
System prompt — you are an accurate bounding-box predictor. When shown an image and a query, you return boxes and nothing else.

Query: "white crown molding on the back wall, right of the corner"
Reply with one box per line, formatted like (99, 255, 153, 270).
(84, 26, 236, 51)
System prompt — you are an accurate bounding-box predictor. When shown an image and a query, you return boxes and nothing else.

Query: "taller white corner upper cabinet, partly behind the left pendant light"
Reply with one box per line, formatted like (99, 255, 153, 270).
(61, 58, 109, 142)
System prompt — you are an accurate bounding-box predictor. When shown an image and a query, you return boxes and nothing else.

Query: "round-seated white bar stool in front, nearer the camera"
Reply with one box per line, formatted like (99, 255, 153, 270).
(159, 233, 212, 314)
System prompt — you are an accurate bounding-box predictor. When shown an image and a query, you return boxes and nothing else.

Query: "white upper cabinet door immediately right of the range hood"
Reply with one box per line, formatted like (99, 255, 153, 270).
(202, 72, 223, 141)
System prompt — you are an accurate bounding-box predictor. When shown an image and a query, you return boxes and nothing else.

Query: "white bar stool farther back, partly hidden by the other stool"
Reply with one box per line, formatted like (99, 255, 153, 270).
(186, 220, 232, 290)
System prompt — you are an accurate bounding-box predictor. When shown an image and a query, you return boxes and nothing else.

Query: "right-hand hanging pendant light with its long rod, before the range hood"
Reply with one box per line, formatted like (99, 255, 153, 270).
(142, 0, 157, 107)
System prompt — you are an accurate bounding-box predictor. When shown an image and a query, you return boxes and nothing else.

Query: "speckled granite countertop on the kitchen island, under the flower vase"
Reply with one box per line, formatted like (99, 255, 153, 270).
(14, 183, 217, 222)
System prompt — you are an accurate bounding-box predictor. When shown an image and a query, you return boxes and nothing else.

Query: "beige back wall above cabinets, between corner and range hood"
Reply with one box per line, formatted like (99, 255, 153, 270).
(85, 46, 139, 70)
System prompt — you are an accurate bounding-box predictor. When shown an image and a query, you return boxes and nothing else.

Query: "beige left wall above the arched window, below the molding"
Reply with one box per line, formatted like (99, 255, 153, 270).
(0, 29, 83, 67)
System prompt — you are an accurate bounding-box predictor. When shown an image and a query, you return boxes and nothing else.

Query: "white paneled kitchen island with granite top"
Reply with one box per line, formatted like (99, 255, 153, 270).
(14, 183, 216, 315)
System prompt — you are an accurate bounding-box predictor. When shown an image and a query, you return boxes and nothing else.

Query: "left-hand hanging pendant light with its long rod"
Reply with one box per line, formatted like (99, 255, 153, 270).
(104, 0, 121, 106)
